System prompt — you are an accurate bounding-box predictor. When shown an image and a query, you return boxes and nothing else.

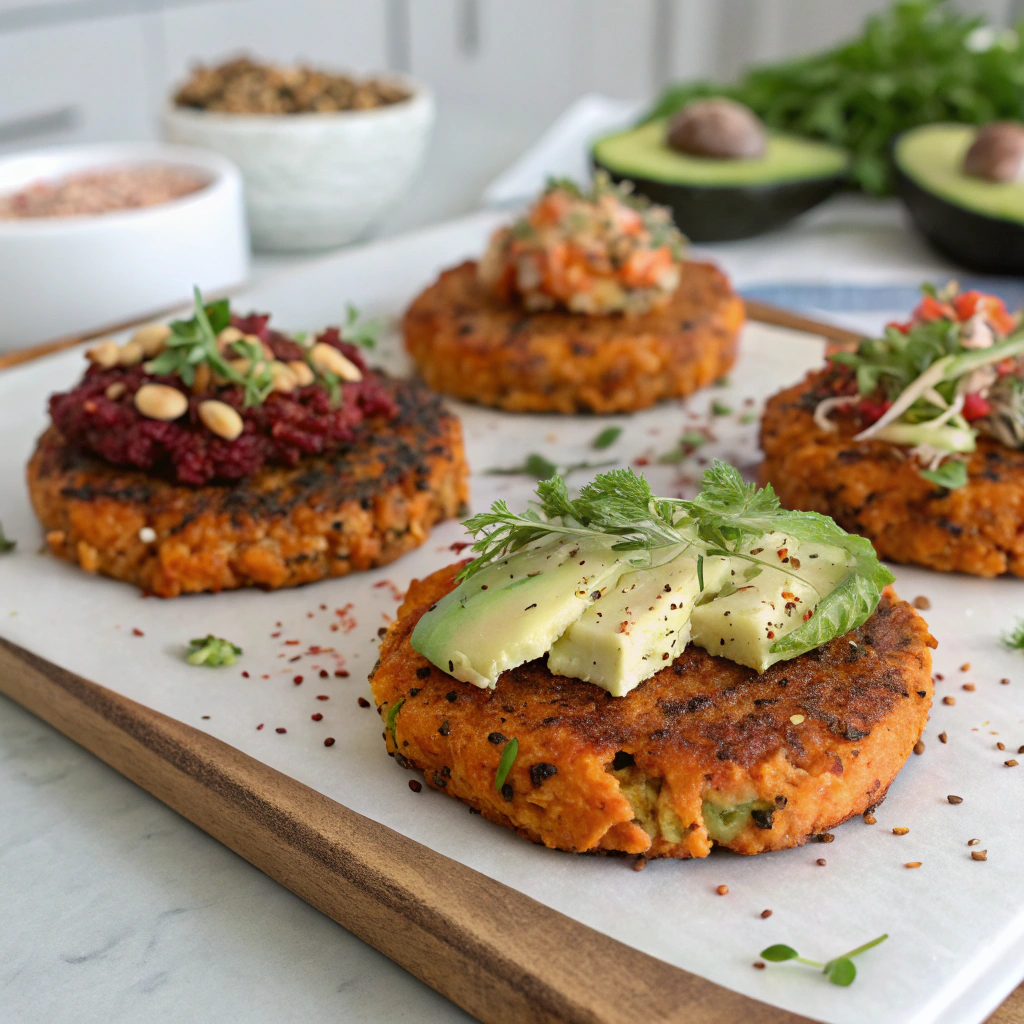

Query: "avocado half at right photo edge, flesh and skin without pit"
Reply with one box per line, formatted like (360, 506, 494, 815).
(892, 124, 1024, 274)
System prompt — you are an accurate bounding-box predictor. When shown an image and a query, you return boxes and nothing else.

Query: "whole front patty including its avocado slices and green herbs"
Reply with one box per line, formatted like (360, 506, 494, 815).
(371, 462, 934, 857)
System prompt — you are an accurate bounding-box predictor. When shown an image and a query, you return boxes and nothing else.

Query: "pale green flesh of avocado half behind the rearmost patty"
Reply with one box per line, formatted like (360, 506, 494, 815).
(594, 121, 848, 188)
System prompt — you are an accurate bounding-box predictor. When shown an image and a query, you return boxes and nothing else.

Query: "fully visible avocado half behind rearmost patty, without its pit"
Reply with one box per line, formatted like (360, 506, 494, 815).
(591, 120, 849, 242)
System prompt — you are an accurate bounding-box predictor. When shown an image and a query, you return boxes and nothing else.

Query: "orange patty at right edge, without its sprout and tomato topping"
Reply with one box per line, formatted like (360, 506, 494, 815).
(761, 372, 1024, 577)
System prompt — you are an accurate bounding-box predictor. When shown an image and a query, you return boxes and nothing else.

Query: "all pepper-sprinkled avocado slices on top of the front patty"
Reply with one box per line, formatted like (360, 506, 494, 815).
(412, 534, 849, 696)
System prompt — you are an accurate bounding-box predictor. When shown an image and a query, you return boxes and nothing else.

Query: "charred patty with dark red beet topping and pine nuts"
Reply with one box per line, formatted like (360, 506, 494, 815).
(28, 292, 468, 597)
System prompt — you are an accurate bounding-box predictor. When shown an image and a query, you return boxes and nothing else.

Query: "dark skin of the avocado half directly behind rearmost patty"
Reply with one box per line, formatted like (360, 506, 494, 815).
(591, 156, 846, 242)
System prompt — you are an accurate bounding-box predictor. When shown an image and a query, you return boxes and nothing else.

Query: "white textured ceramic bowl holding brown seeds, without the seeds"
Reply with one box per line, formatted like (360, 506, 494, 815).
(163, 76, 434, 250)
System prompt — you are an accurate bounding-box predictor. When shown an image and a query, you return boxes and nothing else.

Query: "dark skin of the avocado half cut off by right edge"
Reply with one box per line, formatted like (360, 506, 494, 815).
(893, 160, 1024, 275)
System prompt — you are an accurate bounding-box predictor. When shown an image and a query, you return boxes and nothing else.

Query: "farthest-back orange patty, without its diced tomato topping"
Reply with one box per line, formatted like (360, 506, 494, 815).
(404, 261, 743, 413)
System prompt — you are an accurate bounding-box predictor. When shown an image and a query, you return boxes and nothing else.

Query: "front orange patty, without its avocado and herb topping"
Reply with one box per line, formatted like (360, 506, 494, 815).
(371, 565, 935, 858)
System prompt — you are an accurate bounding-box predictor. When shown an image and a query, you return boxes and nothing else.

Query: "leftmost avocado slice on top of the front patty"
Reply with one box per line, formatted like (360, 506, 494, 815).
(412, 534, 629, 687)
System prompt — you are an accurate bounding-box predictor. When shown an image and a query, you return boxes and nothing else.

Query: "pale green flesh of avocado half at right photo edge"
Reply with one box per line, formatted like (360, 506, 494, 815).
(894, 124, 1024, 222)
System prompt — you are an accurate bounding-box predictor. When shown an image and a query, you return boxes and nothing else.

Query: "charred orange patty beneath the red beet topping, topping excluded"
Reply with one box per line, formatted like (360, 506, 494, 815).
(29, 381, 468, 597)
